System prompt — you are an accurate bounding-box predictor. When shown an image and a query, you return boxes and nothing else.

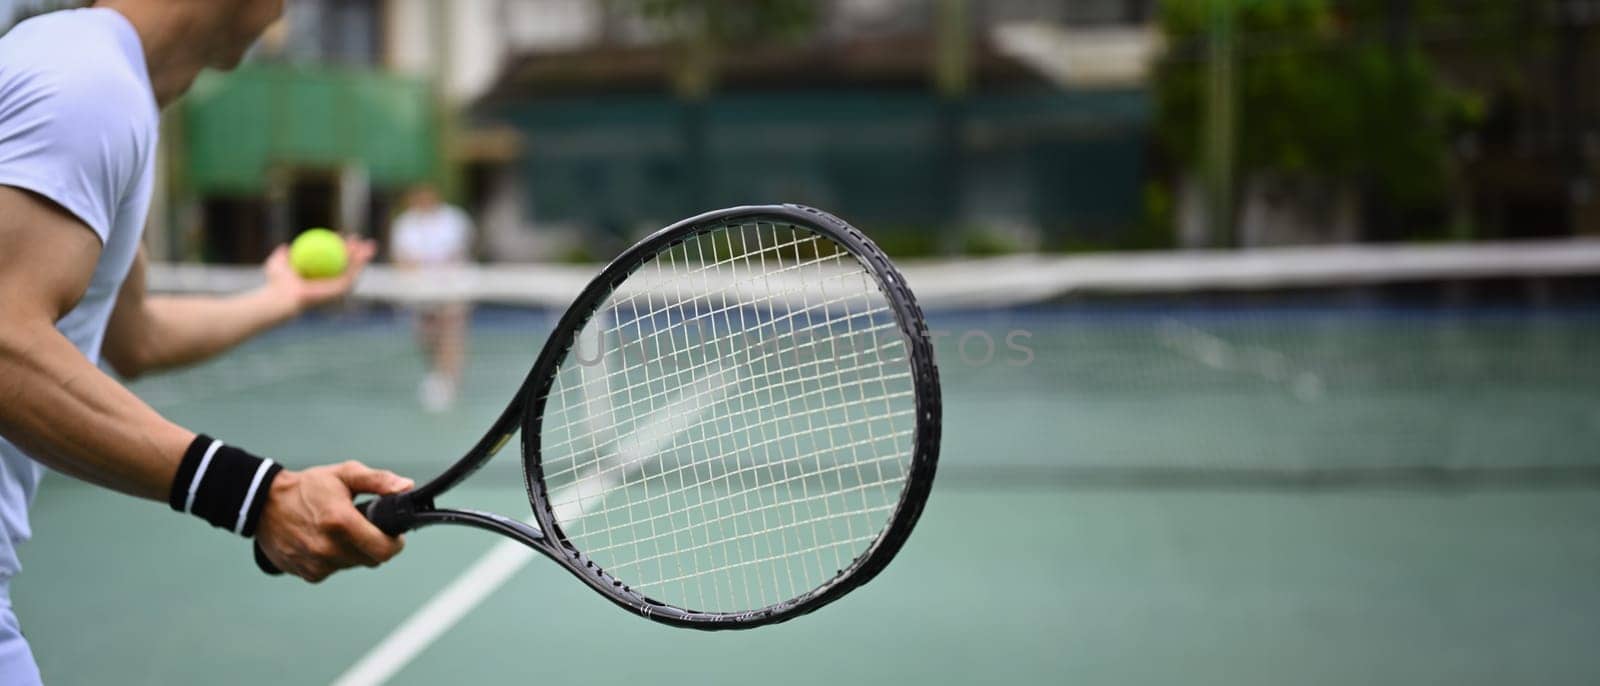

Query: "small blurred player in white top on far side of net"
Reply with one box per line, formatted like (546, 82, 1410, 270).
(389, 184, 472, 413)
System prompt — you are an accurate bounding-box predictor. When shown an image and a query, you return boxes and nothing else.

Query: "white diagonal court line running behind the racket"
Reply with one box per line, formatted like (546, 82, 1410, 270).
(333, 361, 738, 686)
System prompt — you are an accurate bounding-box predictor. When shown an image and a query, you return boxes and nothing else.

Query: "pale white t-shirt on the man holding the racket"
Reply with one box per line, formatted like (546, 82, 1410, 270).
(0, 10, 160, 577)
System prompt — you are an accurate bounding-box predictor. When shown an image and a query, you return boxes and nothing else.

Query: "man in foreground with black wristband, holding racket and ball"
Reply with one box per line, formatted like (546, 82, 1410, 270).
(0, 0, 411, 684)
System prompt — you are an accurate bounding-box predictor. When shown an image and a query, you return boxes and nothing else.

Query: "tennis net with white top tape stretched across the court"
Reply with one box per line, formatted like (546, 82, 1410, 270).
(134, 240, 1600, 488)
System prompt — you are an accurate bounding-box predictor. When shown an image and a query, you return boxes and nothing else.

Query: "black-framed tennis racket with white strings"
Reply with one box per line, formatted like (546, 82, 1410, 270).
(256, 205, 939, 630)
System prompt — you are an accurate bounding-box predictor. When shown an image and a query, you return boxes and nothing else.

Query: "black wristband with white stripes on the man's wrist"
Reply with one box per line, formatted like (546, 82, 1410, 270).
(166, 433, 283, 537)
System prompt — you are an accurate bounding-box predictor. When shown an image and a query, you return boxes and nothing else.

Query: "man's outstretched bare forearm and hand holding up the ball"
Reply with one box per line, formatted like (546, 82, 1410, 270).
(102, 240, 373, 377)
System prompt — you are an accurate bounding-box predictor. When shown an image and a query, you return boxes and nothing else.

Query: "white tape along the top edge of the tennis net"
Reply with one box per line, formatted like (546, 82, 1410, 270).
(149, 238, 1600, 310)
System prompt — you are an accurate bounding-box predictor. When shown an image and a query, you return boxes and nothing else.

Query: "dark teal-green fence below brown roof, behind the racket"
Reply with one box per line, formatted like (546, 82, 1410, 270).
(493, 90, 1150, 243)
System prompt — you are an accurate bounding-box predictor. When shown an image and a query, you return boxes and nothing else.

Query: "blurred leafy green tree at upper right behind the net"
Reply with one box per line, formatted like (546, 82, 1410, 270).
(1155, 0, 1515, 244)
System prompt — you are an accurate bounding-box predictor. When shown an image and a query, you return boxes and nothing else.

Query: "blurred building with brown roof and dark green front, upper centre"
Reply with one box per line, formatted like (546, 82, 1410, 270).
(454, 0, 1155, 257)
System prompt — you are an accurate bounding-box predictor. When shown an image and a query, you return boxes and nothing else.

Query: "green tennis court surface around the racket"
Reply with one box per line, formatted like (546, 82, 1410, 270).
(13, 305, 1600, 684)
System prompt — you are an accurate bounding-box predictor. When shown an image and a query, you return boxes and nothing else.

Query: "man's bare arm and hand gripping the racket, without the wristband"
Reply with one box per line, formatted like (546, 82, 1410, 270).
(0, 187, 411, 580)
